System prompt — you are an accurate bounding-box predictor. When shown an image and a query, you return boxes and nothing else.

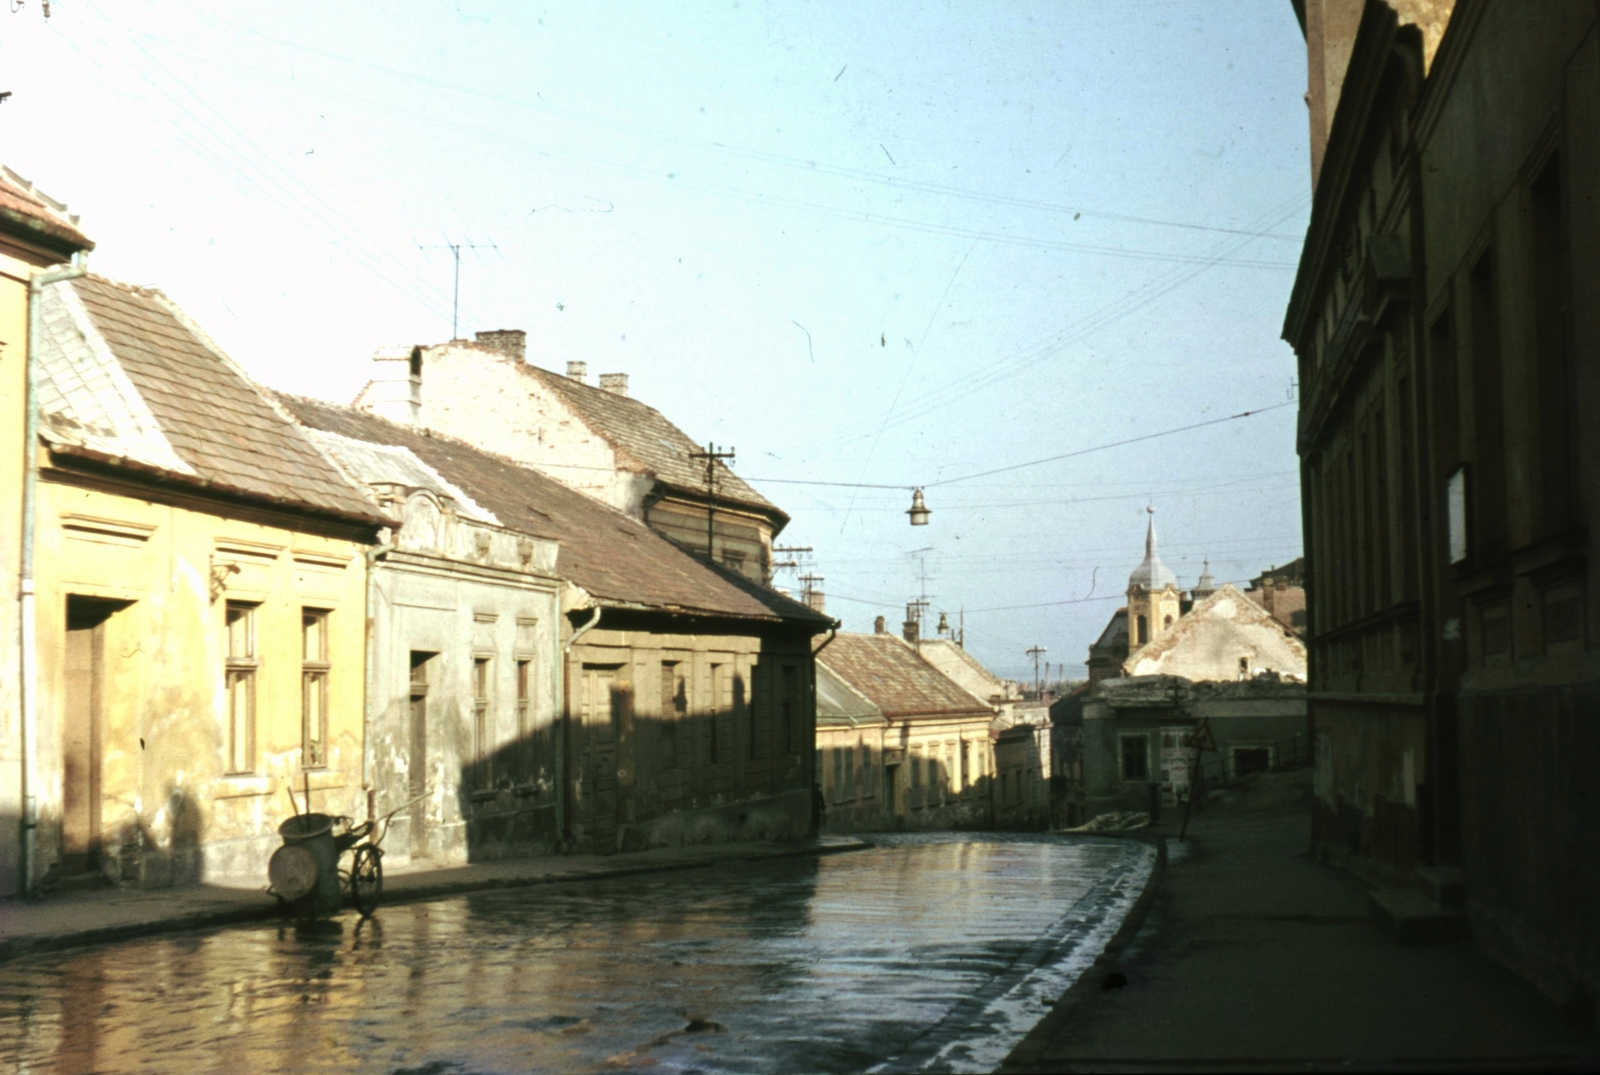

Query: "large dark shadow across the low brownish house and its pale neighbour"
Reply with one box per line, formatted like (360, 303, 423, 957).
(456, 627, 813, 861)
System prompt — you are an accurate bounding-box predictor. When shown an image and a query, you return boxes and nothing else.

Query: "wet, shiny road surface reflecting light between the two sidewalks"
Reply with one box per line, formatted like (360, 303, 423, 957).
(0, 835, 1154, 1075)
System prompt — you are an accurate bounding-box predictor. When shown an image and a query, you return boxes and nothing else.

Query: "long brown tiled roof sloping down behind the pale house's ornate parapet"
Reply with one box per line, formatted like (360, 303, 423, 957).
(278, 395, 832, 632)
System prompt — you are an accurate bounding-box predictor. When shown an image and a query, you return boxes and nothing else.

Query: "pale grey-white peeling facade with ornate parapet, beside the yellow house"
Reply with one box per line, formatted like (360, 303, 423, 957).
(368, 493, 560, 865)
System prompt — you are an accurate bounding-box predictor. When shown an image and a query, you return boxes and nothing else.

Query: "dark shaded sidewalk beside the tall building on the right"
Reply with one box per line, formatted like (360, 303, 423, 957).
(1000, 771, 1600, 1072)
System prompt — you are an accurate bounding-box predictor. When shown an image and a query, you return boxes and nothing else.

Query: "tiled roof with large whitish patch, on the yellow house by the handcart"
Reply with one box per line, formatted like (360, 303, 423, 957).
(40, 277, 382, 522)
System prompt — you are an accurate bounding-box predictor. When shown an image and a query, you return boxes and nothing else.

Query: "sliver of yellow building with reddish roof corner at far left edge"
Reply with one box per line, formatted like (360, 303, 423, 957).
(0, 170, 93, 896)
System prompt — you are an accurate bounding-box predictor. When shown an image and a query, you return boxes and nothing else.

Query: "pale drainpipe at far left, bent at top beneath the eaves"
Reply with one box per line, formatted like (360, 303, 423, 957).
(18, 259, 88, 896)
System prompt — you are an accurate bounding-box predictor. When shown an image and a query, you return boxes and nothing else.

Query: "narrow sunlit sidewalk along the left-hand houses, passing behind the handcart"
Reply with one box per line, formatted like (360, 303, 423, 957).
(0, 835, 872, 961)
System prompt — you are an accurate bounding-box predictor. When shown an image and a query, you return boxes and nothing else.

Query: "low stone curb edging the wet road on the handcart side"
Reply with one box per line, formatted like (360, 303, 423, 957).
(0, 840, 874, 963)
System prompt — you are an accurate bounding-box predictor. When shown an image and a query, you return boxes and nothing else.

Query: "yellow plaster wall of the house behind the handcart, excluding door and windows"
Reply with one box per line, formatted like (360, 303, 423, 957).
(35, 482, 365, 885)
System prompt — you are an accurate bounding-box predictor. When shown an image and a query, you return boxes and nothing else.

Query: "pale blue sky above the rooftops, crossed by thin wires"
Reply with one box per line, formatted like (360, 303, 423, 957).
(0, 0, 1310, 678)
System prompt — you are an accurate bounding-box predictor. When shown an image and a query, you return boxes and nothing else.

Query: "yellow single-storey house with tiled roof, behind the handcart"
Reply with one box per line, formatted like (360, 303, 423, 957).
(30, 275, 386, 886)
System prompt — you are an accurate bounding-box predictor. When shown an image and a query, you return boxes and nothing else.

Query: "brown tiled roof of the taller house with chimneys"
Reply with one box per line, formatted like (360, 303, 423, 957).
(517, 363, 789, 522)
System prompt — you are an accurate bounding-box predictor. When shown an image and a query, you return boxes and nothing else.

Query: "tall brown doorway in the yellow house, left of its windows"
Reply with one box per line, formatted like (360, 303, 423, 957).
(61, 597, 128, 877)
